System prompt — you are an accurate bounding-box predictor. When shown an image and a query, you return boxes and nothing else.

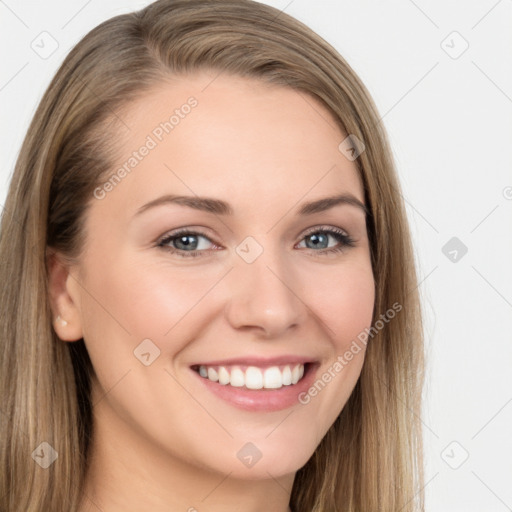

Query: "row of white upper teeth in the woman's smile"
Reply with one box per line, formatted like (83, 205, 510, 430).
(199, 364, 304, 389)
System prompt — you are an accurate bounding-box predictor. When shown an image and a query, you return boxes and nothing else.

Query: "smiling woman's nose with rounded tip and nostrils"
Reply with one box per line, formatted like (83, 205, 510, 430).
(226, 249, 307, 338)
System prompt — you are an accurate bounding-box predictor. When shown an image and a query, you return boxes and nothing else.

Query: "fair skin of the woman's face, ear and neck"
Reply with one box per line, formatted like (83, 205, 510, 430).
(50, 72, 374, 512)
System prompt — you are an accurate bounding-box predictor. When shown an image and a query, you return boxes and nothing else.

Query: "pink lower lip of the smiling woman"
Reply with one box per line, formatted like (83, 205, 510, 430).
(191, 364, 318, 412)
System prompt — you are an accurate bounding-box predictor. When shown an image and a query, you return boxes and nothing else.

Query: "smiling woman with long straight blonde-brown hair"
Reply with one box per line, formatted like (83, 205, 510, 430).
(0, 0, 423, 512)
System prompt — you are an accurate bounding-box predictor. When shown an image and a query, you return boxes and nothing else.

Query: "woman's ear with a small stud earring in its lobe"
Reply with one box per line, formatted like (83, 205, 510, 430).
(46, 248, 83, 341)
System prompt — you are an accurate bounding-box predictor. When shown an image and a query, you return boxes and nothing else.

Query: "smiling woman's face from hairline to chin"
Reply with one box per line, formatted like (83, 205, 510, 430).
(59, 73, 374, 479)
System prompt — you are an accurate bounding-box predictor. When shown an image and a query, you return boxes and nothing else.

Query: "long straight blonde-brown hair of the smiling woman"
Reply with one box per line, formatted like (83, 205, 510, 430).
(0, 0, 423, 512)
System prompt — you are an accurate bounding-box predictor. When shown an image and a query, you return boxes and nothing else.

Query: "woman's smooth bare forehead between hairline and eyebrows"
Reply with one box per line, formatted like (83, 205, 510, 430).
(98, 72, 364, 214)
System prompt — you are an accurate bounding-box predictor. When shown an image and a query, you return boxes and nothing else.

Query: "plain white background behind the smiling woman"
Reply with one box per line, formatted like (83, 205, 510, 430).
(0, 0, 512, 512)
